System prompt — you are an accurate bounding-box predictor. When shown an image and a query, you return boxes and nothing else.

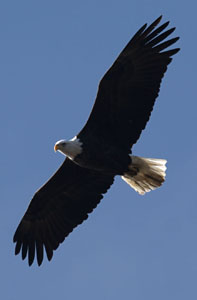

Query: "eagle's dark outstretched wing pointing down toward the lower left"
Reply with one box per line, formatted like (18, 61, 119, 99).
(14, 158, 114, 265)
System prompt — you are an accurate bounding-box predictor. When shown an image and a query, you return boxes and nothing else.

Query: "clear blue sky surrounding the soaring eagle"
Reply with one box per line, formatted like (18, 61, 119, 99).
(0, 0, 197, 300)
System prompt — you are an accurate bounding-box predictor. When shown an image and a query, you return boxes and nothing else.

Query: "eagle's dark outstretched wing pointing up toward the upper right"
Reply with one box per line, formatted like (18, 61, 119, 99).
(78, 17, 179, 153)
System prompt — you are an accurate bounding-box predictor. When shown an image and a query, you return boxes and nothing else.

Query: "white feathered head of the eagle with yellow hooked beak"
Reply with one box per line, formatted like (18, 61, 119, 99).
(54, 137, 82, 160)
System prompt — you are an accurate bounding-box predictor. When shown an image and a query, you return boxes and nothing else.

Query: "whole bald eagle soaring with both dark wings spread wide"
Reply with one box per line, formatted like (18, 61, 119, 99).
(13, 16, 180, 266)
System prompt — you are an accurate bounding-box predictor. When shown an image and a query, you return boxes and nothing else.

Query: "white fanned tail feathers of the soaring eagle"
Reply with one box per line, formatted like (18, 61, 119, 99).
(122, 155, 167, 195)
